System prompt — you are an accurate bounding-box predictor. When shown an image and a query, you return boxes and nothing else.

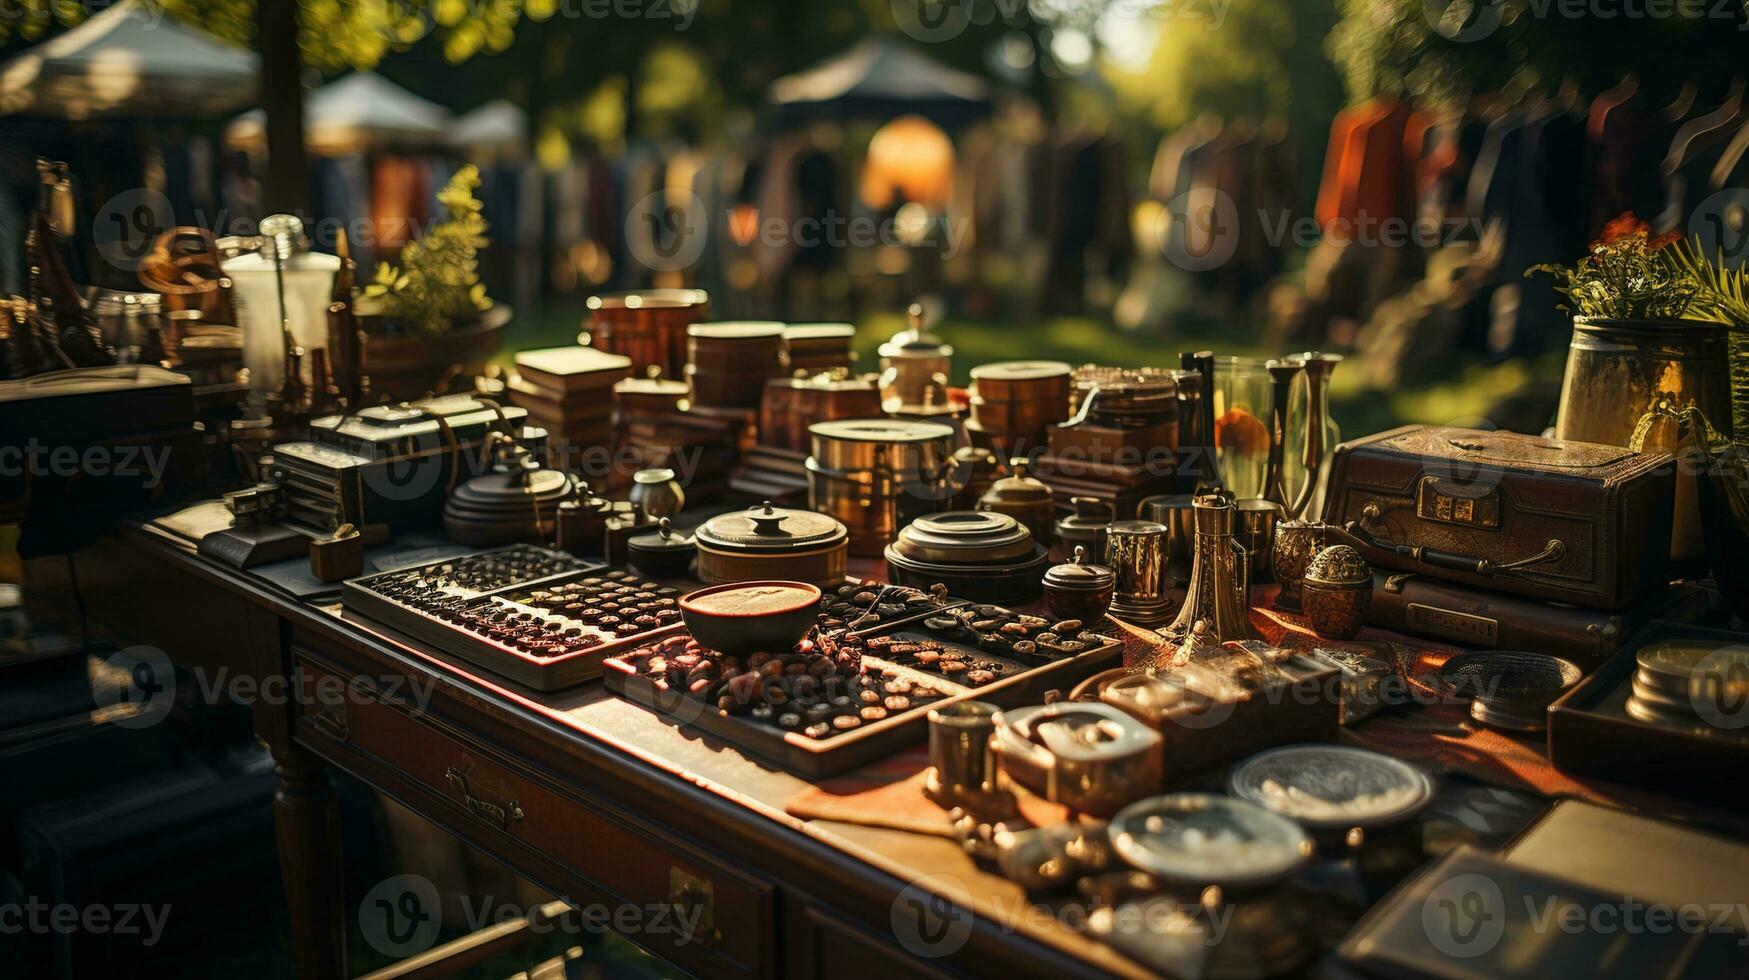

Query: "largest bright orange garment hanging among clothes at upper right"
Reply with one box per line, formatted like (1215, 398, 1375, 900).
(1317, 98, 1410, 238)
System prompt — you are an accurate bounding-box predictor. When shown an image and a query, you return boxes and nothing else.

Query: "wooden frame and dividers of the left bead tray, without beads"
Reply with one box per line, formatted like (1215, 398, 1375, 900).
(341, 562, 686, 691)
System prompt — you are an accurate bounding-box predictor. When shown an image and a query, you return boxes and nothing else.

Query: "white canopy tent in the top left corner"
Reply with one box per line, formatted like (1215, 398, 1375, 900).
(0, 0, 261, 119)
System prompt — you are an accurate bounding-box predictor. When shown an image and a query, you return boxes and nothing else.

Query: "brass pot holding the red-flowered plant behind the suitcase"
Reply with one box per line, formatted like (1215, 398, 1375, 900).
(1555, 317, 1732, 562)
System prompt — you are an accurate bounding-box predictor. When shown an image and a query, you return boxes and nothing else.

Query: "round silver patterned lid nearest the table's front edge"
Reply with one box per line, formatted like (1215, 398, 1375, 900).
(1109, 793, 1313, 887)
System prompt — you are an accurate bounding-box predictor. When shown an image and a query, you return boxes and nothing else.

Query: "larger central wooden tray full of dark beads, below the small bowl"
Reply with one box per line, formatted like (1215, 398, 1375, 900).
(602, 616, 1123, 777)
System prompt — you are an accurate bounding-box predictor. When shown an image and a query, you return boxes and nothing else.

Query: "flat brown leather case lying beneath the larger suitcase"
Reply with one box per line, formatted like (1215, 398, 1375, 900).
(1366, 572, 1725, 672)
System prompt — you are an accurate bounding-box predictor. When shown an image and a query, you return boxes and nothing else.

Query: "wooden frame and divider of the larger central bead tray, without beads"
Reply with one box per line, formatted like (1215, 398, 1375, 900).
(602, 628, 1123, 779)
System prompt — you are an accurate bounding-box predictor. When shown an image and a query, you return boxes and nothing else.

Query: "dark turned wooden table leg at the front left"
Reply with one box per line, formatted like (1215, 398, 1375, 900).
(273, 746, 346, 980)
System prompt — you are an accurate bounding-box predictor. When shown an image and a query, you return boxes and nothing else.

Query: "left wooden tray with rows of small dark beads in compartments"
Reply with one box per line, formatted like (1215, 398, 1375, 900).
(341, 553, 682, 691)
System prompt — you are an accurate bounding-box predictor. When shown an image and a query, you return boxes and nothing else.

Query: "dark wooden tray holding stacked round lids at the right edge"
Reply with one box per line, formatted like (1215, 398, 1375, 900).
(1548, 620, 1749, 803)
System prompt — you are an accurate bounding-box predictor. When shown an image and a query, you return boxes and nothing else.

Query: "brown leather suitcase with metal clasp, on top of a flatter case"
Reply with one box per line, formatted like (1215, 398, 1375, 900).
(1324, 425, 1676, 609)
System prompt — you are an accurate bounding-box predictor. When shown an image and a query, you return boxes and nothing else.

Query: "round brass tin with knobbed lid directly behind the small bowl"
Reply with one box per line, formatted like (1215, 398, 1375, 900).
(694, 501, 850, 586)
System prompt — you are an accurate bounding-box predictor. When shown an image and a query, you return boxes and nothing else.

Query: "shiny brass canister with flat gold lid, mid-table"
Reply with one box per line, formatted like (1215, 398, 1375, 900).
(806, 418, 955, 557)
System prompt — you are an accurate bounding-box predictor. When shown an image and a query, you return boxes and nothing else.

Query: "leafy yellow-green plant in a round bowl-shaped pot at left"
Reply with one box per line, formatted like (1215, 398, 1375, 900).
(357, 165, 511, 401)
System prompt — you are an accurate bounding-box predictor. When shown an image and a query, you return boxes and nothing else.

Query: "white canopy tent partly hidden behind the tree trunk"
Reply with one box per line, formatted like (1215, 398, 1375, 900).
(226, 72, 449, 152)
